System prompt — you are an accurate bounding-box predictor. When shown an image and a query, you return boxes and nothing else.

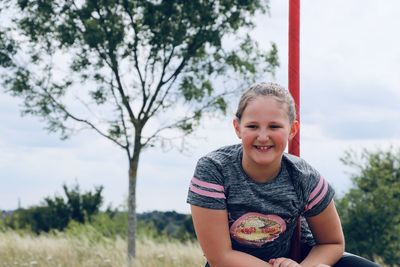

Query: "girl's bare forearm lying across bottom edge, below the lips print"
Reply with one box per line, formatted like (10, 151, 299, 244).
(207, 250, 272, 267)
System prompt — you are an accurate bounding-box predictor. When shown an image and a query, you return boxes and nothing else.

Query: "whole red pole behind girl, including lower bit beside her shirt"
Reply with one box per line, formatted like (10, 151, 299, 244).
(288, 0, 302, 263)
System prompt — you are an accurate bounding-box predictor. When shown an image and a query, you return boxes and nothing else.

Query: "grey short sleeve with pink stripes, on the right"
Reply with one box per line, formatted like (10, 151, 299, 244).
(304, 169, 335, 217)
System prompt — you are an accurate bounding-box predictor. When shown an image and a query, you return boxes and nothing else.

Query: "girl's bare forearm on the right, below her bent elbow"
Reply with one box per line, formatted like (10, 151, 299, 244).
(301, 244, 344, 267)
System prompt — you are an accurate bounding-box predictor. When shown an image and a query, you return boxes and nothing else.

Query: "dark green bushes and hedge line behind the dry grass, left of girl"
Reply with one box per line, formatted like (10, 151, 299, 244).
(0, 185, 195, 241)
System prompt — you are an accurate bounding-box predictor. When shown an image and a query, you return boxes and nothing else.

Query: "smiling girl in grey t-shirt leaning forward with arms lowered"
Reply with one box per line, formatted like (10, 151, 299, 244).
(187, 83, 377, 267)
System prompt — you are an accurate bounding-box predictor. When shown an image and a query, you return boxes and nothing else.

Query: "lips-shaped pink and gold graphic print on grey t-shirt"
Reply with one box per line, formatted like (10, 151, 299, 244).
(230, 212, 286, 247)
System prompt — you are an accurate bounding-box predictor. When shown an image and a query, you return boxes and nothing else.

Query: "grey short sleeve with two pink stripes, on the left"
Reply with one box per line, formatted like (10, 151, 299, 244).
(187, 157, 226, 210)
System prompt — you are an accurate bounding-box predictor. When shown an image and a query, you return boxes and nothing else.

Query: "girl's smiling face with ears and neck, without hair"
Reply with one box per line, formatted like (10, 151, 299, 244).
(234, 96, 297, 174)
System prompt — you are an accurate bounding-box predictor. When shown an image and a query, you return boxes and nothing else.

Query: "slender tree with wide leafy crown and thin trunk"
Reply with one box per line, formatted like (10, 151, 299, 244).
(0, 0, 278, 264)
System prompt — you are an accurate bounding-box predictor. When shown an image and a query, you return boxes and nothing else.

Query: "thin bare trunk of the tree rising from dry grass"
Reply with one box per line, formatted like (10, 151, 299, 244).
(128, 135, 142, 267)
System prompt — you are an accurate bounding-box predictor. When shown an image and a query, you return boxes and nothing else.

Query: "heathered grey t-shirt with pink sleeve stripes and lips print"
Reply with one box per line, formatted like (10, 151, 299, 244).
(187, 144, 334, 260)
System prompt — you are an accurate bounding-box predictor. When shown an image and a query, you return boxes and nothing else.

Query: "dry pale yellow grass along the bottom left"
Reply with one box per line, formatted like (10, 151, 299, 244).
(0, 232, 205, 267)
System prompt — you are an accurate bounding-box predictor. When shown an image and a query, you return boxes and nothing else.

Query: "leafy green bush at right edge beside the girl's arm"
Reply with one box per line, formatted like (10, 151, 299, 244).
(338, 149, 400, 266)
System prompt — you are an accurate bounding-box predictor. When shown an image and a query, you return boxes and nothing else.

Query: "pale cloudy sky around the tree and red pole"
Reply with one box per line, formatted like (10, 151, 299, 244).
(0, 0, 400, 213)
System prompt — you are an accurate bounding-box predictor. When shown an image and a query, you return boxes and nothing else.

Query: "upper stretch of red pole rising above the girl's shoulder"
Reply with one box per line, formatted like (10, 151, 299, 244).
(288, 0, 300, 156)
